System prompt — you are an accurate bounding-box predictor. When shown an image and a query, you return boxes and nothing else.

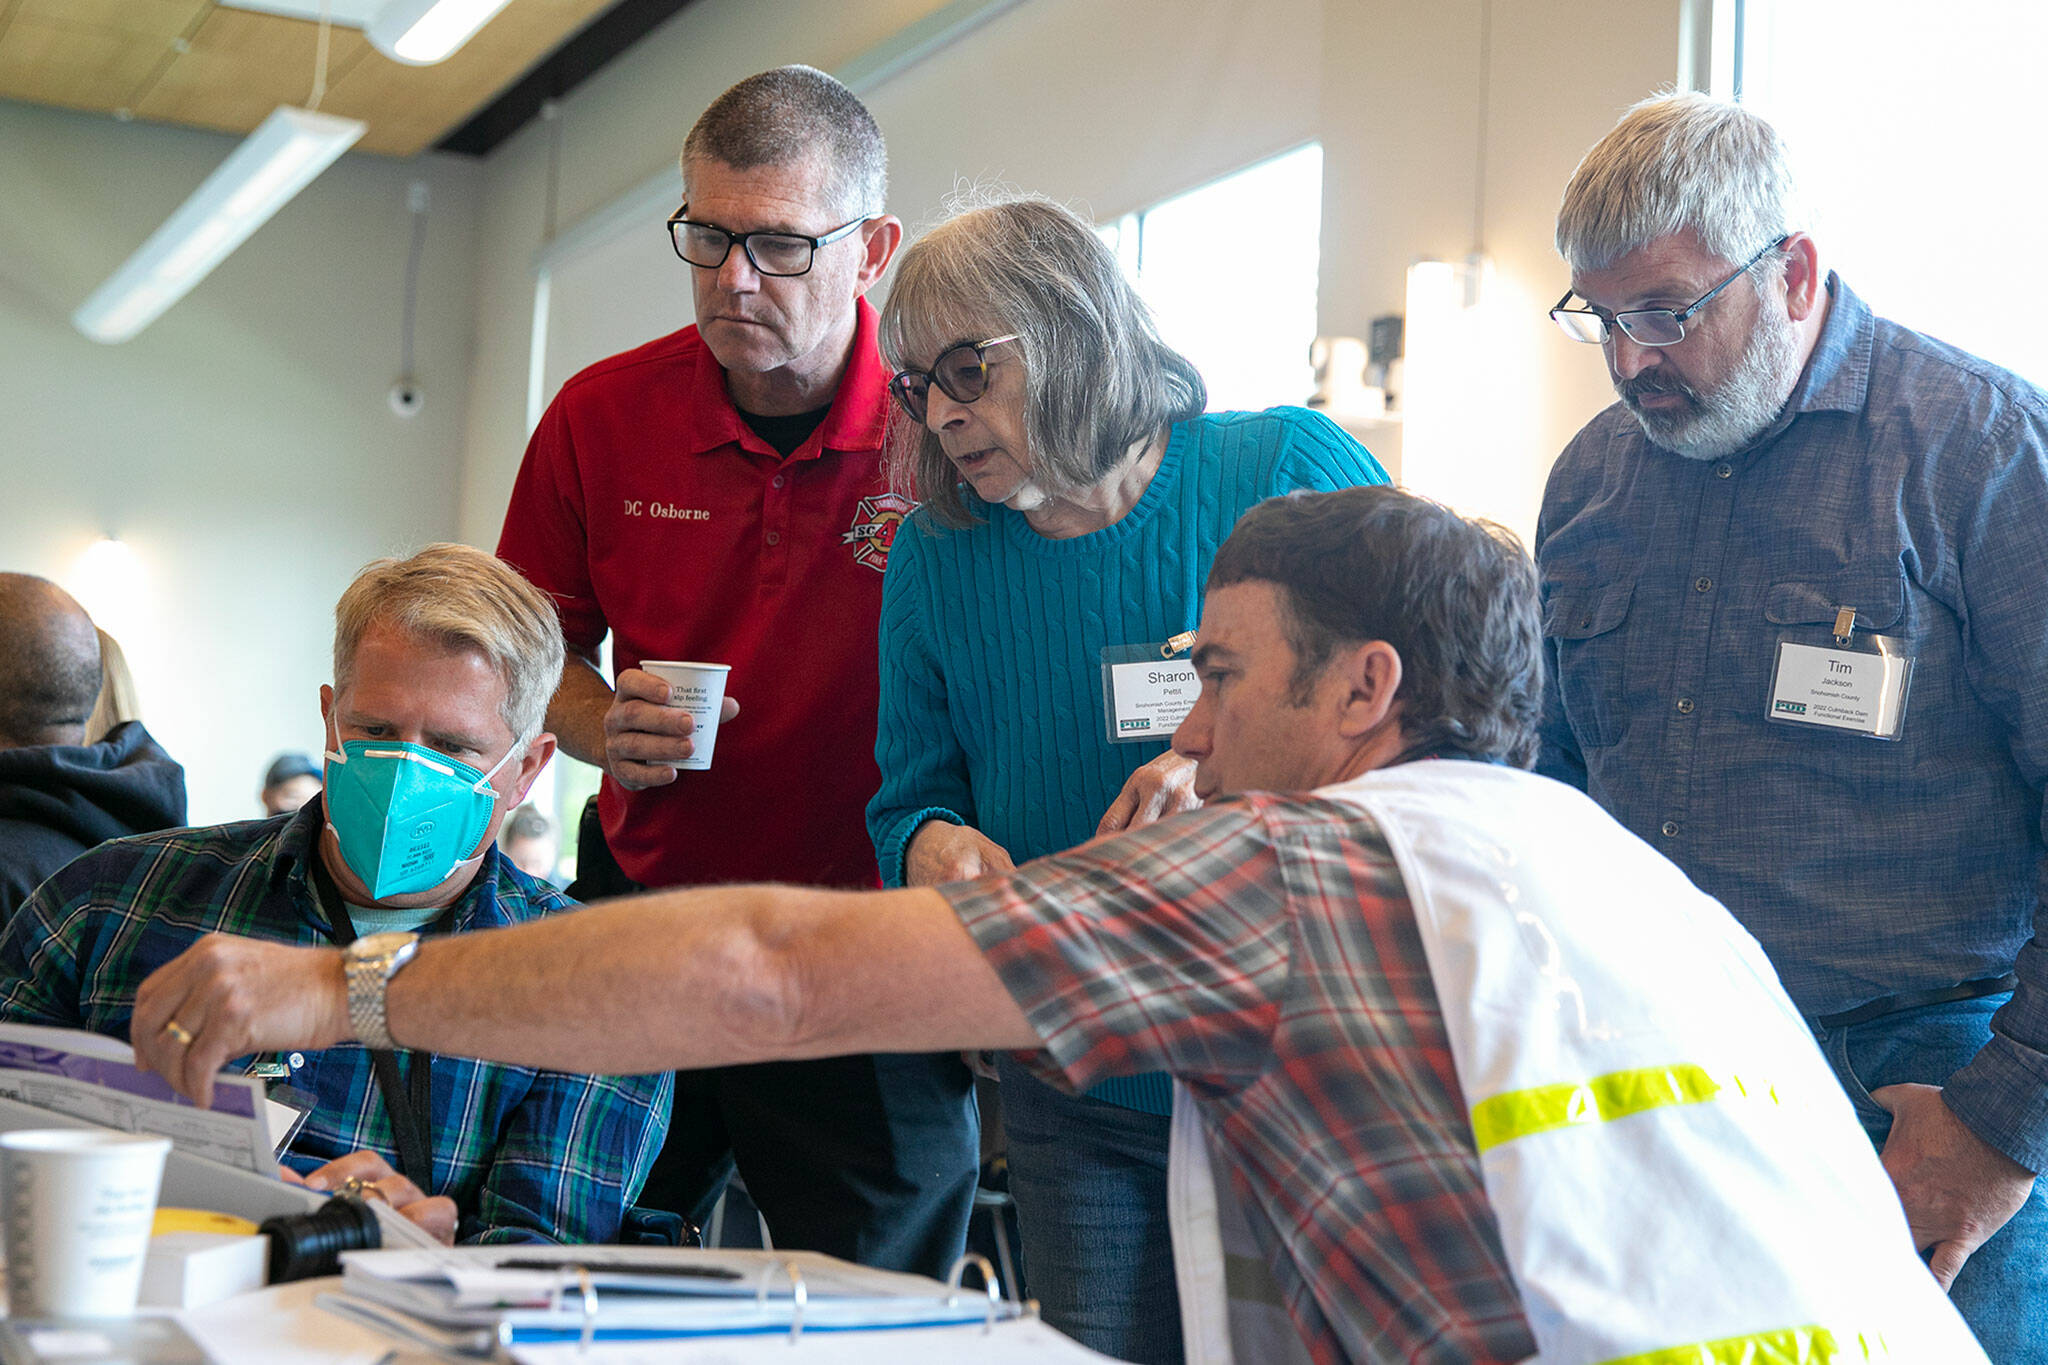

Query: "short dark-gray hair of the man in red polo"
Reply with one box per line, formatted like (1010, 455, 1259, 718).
(682, 65, 889, 217)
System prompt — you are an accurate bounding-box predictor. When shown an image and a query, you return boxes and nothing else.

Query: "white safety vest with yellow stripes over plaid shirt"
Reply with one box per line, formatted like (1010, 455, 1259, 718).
(1167, 761, 1985, 1365)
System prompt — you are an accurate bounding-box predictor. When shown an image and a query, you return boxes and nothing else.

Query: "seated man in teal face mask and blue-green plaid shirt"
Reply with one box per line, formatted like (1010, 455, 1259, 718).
(0, 544, 670, 1242)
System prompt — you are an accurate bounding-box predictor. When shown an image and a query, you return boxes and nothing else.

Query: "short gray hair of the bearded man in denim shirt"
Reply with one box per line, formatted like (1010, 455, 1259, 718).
(1556, 94, 1806, 276)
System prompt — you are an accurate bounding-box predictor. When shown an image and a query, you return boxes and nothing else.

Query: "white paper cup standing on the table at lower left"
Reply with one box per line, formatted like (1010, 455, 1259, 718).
(0, 1128, 170, 1318)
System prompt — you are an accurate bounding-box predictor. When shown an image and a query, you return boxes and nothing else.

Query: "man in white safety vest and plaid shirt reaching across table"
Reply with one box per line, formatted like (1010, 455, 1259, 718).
(137, 487, 1982, 1365)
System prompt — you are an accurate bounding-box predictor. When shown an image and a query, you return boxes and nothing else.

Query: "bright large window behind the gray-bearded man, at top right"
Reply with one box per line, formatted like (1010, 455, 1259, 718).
(1739, 0, 2048, 383)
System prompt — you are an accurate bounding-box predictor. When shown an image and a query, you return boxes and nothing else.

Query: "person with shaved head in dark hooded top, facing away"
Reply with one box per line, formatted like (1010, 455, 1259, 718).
(0, 573, 184, 923)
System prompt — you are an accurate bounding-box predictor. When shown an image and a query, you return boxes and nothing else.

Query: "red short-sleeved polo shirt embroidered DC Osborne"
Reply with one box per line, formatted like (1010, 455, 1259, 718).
(498, 301, 909, 886)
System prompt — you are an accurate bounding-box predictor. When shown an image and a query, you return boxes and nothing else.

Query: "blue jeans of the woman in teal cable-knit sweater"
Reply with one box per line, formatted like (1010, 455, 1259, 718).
(997, 1056, 1182, 1365)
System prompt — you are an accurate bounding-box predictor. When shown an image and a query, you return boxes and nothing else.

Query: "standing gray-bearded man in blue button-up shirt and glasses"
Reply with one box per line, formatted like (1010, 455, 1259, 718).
(1536, 94, 2048, 1361)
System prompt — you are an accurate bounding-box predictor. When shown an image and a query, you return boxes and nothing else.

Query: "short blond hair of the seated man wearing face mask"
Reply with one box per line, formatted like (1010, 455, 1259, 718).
(334, 544, 563, 749)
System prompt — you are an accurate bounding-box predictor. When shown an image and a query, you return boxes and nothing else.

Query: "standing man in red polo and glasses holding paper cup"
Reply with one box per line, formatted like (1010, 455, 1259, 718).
(498, 65, 977, 1275)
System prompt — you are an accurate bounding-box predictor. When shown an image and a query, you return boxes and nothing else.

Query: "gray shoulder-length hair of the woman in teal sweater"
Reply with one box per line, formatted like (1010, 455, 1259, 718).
(881, 196, 1208, 526)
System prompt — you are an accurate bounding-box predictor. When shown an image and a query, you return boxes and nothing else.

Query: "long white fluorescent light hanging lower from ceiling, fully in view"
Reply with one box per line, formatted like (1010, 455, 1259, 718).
(72, 106, 369, 344)
